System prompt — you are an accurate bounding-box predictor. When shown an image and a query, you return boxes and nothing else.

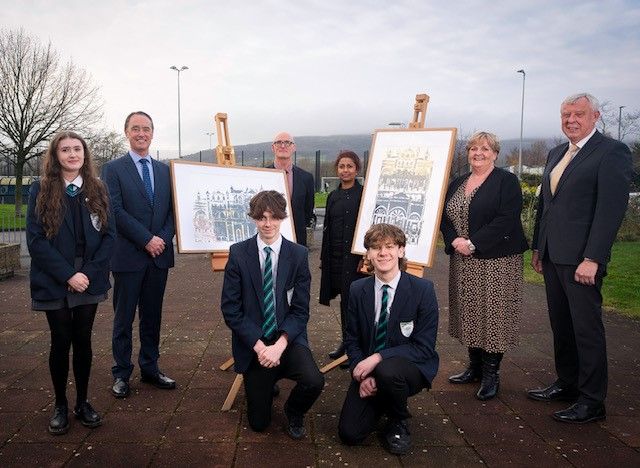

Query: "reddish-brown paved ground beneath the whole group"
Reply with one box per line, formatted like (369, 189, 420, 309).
(0, 234, 640, 467)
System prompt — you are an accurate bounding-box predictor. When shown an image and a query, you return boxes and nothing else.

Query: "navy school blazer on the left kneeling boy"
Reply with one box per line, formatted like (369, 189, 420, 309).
(220, 235, 311, 373)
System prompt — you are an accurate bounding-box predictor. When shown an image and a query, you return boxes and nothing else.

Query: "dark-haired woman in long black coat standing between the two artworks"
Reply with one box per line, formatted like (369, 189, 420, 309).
(320, 151, 363, 359)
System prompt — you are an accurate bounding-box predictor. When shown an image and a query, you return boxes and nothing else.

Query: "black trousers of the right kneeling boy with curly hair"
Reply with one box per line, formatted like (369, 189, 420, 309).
(338, 357, 429, 445)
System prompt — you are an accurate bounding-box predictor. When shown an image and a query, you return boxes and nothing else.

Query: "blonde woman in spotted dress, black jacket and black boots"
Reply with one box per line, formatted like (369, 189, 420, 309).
(440, 132, 528, 400)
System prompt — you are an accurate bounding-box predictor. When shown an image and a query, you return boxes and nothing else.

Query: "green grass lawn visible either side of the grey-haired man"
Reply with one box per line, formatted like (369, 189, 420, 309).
(524, 245, 640, 319)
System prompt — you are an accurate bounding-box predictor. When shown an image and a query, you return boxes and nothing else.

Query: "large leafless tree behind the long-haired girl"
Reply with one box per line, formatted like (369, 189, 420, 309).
(0, 29, 102, 216)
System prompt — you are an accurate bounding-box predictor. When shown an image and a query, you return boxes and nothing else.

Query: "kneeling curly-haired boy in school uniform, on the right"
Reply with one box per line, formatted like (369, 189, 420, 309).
(338, 224, 438, 455)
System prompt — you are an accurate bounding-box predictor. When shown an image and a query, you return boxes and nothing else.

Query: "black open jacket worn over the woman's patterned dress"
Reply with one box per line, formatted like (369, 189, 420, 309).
(440, 167, 529, 259)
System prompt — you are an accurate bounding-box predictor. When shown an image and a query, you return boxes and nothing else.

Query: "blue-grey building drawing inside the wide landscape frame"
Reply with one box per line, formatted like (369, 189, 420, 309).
(193, 186, 262, 244)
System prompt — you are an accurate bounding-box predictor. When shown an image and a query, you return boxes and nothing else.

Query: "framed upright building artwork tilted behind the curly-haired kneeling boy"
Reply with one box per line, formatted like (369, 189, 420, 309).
(351, 128, 456, 267)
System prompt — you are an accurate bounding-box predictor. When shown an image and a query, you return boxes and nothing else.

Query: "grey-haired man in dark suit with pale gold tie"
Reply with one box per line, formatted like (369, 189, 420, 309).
(528, 94, 631, 423)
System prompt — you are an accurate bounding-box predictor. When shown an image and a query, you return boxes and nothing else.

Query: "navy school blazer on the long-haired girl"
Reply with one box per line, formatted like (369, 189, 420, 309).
(27, 181, 116, 301)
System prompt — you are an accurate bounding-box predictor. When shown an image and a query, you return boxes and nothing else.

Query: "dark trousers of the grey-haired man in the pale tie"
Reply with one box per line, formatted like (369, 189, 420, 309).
(542, 258, 607, 404)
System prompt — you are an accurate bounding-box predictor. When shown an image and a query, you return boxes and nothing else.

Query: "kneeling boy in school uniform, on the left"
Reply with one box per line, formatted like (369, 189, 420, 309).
(221, 190, 324, 439)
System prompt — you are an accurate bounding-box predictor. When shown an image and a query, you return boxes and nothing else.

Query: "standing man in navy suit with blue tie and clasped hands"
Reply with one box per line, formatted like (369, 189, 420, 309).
(102, 111, 176, 398)
